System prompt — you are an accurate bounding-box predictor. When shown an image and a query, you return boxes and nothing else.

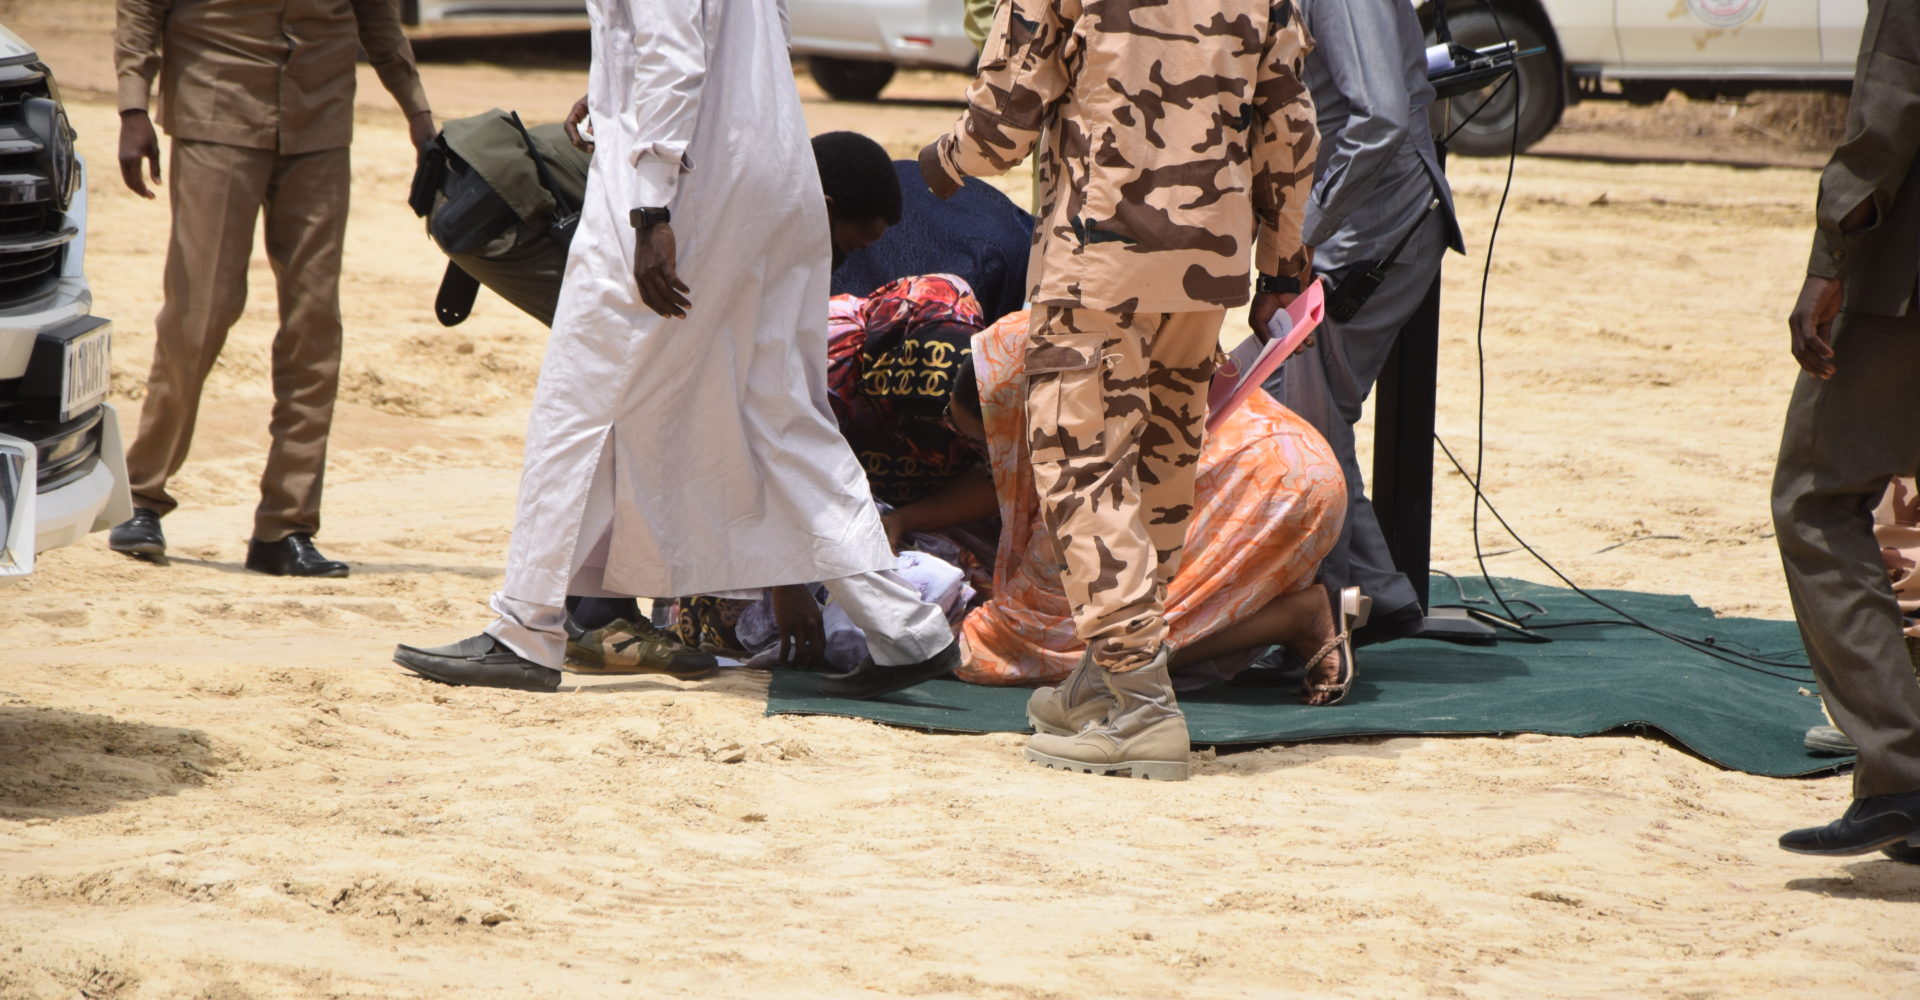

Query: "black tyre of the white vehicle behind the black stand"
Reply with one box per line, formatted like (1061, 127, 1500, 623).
(1434, 0, 1567, 155)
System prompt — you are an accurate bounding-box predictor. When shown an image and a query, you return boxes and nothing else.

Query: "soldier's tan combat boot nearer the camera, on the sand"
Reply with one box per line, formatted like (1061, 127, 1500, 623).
(1027, 645, 1188, 781)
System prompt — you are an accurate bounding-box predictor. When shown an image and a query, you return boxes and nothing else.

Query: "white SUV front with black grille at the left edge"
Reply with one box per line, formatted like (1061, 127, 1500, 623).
(0, 27, 132, 583)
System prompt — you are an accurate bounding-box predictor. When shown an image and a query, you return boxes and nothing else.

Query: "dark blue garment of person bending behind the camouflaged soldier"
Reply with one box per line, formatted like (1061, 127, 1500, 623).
(833, 159, 1033, 322)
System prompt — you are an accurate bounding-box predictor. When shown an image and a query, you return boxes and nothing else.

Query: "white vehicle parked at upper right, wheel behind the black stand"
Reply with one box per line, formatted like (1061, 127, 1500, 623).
(1443, 0, 1866, 155)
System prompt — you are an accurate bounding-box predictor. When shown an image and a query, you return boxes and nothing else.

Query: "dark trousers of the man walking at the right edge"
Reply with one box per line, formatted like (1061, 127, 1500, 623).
(1774, 313, 1920, 798)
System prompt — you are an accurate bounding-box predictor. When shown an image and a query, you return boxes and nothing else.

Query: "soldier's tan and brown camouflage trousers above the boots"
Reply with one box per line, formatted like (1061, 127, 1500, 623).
(1027, 305, 1227, 670)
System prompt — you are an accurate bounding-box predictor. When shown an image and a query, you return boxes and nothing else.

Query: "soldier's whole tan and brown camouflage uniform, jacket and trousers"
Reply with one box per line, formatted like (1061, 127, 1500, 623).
(935, 0, 1317, 670)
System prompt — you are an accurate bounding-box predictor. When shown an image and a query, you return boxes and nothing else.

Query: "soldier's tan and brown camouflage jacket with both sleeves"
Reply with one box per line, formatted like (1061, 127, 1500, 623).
(937, 0, 1317, 313)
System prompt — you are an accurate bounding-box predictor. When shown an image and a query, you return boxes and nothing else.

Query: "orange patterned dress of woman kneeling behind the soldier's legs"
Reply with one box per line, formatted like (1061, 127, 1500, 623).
(958, 313, 1346, 685)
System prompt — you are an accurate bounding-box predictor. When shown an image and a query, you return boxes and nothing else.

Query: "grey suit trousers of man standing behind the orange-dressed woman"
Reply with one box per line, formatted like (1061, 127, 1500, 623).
(1263, 213, 1446, 616)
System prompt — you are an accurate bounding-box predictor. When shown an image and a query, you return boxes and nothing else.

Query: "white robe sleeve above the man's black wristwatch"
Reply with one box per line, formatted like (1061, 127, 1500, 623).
(620, 0, 707, 207)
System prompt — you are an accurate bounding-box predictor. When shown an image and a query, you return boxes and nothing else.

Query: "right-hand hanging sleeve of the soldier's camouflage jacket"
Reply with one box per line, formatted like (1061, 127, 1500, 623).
(1254, 0, 1319, 280)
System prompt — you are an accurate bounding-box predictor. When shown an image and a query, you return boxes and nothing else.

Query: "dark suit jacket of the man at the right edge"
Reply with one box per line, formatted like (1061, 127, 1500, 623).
(1807, 0, 1920, 317)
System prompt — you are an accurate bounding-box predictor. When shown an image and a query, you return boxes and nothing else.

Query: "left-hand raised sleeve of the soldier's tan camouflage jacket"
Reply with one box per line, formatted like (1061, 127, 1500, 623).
(939, 0, 1079, 180)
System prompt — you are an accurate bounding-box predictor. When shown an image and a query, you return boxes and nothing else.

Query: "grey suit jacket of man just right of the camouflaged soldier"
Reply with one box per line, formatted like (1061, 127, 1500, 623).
(1294, 0, 1461, 271)
